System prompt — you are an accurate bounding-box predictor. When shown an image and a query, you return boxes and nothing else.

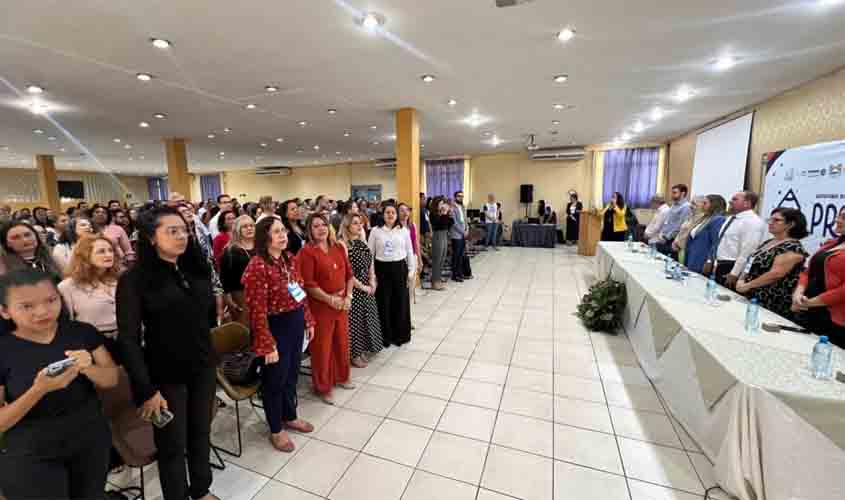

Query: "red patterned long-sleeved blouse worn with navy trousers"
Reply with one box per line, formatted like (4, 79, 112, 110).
(241, 254, 314, 356)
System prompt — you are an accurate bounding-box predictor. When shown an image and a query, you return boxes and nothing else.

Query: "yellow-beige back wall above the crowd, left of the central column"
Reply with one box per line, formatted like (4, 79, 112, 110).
(223, 163, 396, 201)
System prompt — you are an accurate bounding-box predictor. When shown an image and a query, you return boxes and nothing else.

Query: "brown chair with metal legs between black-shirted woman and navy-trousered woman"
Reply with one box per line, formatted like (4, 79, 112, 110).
(211, 321, 260, 458)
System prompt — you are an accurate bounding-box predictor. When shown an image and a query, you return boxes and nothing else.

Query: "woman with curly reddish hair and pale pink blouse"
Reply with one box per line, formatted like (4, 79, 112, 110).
(59, 235, 121, 364)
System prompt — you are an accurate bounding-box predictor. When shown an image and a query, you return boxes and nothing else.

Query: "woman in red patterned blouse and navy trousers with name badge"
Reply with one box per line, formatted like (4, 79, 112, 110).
(242, 217, 314, 453)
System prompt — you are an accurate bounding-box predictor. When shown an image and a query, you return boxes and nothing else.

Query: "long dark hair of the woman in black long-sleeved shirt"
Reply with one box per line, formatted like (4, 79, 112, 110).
(133, 205, 211, 278)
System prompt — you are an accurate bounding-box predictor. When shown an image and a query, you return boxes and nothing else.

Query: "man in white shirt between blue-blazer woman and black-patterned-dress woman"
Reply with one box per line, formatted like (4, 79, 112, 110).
(715, 191, 768, 288)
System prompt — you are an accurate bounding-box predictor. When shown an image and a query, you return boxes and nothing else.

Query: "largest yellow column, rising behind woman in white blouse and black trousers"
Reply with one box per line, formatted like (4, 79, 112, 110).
(396, 108, 420, 228)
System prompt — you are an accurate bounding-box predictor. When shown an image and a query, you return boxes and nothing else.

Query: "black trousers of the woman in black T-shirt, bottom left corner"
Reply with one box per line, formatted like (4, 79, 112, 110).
(0, 410, 111, 500)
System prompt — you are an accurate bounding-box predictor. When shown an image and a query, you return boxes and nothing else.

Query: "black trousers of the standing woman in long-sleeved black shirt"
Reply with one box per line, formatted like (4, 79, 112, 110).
(154, 366, 217, 500)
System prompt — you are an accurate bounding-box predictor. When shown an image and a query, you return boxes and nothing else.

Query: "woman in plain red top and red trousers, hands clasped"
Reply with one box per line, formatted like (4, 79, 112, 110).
(296, 213, 355, 405)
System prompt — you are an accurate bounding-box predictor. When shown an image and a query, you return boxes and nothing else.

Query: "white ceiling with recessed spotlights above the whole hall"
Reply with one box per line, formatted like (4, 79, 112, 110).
(0, 0, 845, 174)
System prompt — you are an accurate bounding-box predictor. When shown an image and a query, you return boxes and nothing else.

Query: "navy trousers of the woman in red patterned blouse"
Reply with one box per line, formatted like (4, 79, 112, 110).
(261, 308, 305, 434)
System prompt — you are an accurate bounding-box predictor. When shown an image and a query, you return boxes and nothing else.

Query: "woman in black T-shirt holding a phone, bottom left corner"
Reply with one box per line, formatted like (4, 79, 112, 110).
(0, 268, 118, 500)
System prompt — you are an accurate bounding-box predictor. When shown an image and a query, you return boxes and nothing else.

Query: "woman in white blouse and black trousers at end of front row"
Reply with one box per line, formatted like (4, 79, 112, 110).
(367, 203, 417, 347)
